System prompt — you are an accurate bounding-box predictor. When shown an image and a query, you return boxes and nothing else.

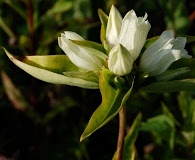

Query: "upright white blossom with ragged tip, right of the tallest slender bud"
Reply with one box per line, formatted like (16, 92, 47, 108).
(119, 10, 151, 61)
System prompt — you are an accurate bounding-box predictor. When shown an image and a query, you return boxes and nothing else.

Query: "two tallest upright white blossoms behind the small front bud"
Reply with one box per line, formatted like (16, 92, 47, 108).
(106, 6, 151, 61)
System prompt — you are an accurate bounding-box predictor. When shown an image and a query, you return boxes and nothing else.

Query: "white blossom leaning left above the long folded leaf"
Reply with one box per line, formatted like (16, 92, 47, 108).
(58, 31, 107, 71)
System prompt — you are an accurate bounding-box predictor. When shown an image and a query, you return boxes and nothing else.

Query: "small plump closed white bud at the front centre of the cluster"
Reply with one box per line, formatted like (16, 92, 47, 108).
(108, 44, 133, 76)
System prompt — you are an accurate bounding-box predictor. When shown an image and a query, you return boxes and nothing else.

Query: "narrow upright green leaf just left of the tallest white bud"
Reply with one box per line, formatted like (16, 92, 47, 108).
(98, 9, 108, 44)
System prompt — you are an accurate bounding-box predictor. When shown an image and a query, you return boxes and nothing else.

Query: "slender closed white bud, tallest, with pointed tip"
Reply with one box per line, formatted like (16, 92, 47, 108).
(106, 6, 122, 49)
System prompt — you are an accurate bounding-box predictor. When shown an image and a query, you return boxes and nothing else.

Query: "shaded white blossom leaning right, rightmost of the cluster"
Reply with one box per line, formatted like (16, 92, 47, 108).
(140, 30, 191, 76)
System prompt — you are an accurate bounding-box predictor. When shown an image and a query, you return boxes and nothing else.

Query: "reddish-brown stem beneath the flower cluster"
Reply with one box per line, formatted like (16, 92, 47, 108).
(116, 106, 126, 160)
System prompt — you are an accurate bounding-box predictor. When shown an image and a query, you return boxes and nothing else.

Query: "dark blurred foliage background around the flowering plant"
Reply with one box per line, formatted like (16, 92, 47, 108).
(0, 0, 195, 160)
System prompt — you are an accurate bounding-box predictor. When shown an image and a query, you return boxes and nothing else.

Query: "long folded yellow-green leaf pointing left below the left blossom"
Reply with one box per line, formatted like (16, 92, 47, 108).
(2, 48, 99, 89)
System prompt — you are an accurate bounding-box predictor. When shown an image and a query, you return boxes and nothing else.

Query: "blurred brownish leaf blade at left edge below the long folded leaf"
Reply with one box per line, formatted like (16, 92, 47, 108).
(1, 71, 29, 111)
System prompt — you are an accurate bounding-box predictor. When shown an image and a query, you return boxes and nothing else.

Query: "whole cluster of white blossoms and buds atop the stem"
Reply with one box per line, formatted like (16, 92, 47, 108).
(58, 6, 190, 79)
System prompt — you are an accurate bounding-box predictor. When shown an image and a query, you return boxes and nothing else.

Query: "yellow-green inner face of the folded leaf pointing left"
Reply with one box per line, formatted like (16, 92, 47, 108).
(24, 55, 99, 83)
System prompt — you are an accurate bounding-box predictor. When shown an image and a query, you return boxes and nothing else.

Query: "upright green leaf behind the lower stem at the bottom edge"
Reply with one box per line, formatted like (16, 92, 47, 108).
(112, 113, 142, 160)
